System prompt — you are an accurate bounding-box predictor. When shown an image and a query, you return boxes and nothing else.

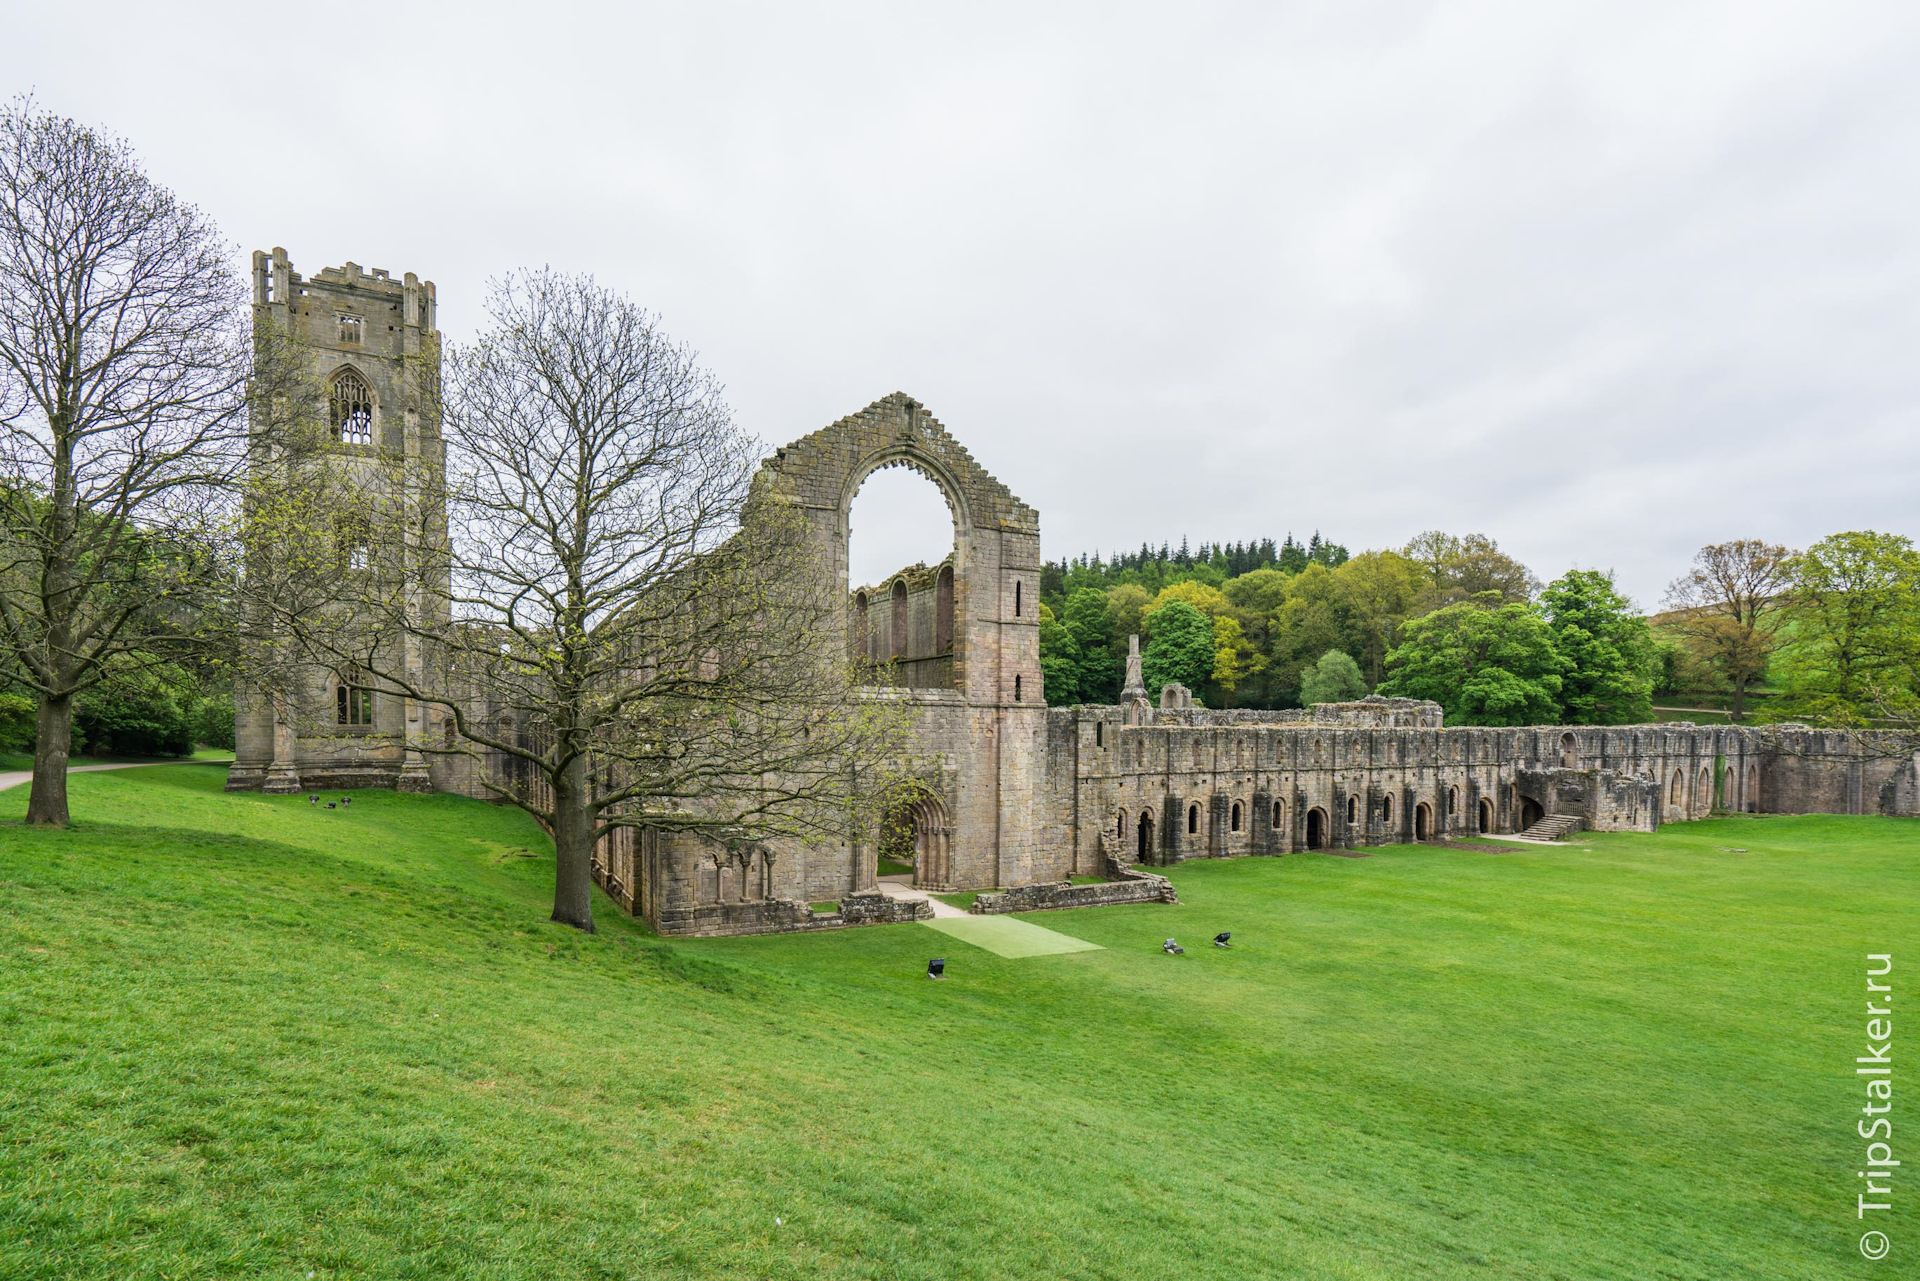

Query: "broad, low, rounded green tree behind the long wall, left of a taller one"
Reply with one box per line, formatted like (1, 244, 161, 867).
(1379, 597, 1569, 726)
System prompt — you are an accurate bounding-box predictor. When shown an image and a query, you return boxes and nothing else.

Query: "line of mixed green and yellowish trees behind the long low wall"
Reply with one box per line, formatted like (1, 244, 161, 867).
(1041, 530, 1920, 726)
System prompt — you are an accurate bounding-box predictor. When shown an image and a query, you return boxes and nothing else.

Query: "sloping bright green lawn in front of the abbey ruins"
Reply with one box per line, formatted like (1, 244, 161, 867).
(0, 766, 1920, 1281)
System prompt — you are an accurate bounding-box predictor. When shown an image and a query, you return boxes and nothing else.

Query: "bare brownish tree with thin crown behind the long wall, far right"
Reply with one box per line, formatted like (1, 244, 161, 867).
(1667, 538, 1793, 722)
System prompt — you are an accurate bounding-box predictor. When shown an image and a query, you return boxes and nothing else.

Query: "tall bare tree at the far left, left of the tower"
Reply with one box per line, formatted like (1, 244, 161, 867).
(0, 98, 248, 826)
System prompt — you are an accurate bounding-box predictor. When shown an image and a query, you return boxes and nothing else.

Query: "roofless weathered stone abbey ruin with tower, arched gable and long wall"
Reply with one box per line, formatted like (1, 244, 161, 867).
(228, 250, 1920, 935)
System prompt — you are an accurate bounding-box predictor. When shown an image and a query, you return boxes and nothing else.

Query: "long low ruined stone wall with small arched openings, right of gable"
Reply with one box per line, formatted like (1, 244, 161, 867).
(1041, 699, 1843, 876)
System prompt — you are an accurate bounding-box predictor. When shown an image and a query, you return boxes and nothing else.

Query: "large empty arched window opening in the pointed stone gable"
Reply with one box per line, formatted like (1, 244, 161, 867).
(847, 463, 960, 689)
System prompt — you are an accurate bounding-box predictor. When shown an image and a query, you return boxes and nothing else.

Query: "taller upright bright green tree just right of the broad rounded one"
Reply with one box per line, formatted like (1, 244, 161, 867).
(1540, 568, 1657, 724)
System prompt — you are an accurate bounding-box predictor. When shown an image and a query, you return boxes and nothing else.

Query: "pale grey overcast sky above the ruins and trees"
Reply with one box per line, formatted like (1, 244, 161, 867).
(0, 0, 1920, 605)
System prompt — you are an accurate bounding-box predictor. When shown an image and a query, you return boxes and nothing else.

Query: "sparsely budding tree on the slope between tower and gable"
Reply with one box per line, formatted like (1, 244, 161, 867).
(250, 271, 902, 930)
